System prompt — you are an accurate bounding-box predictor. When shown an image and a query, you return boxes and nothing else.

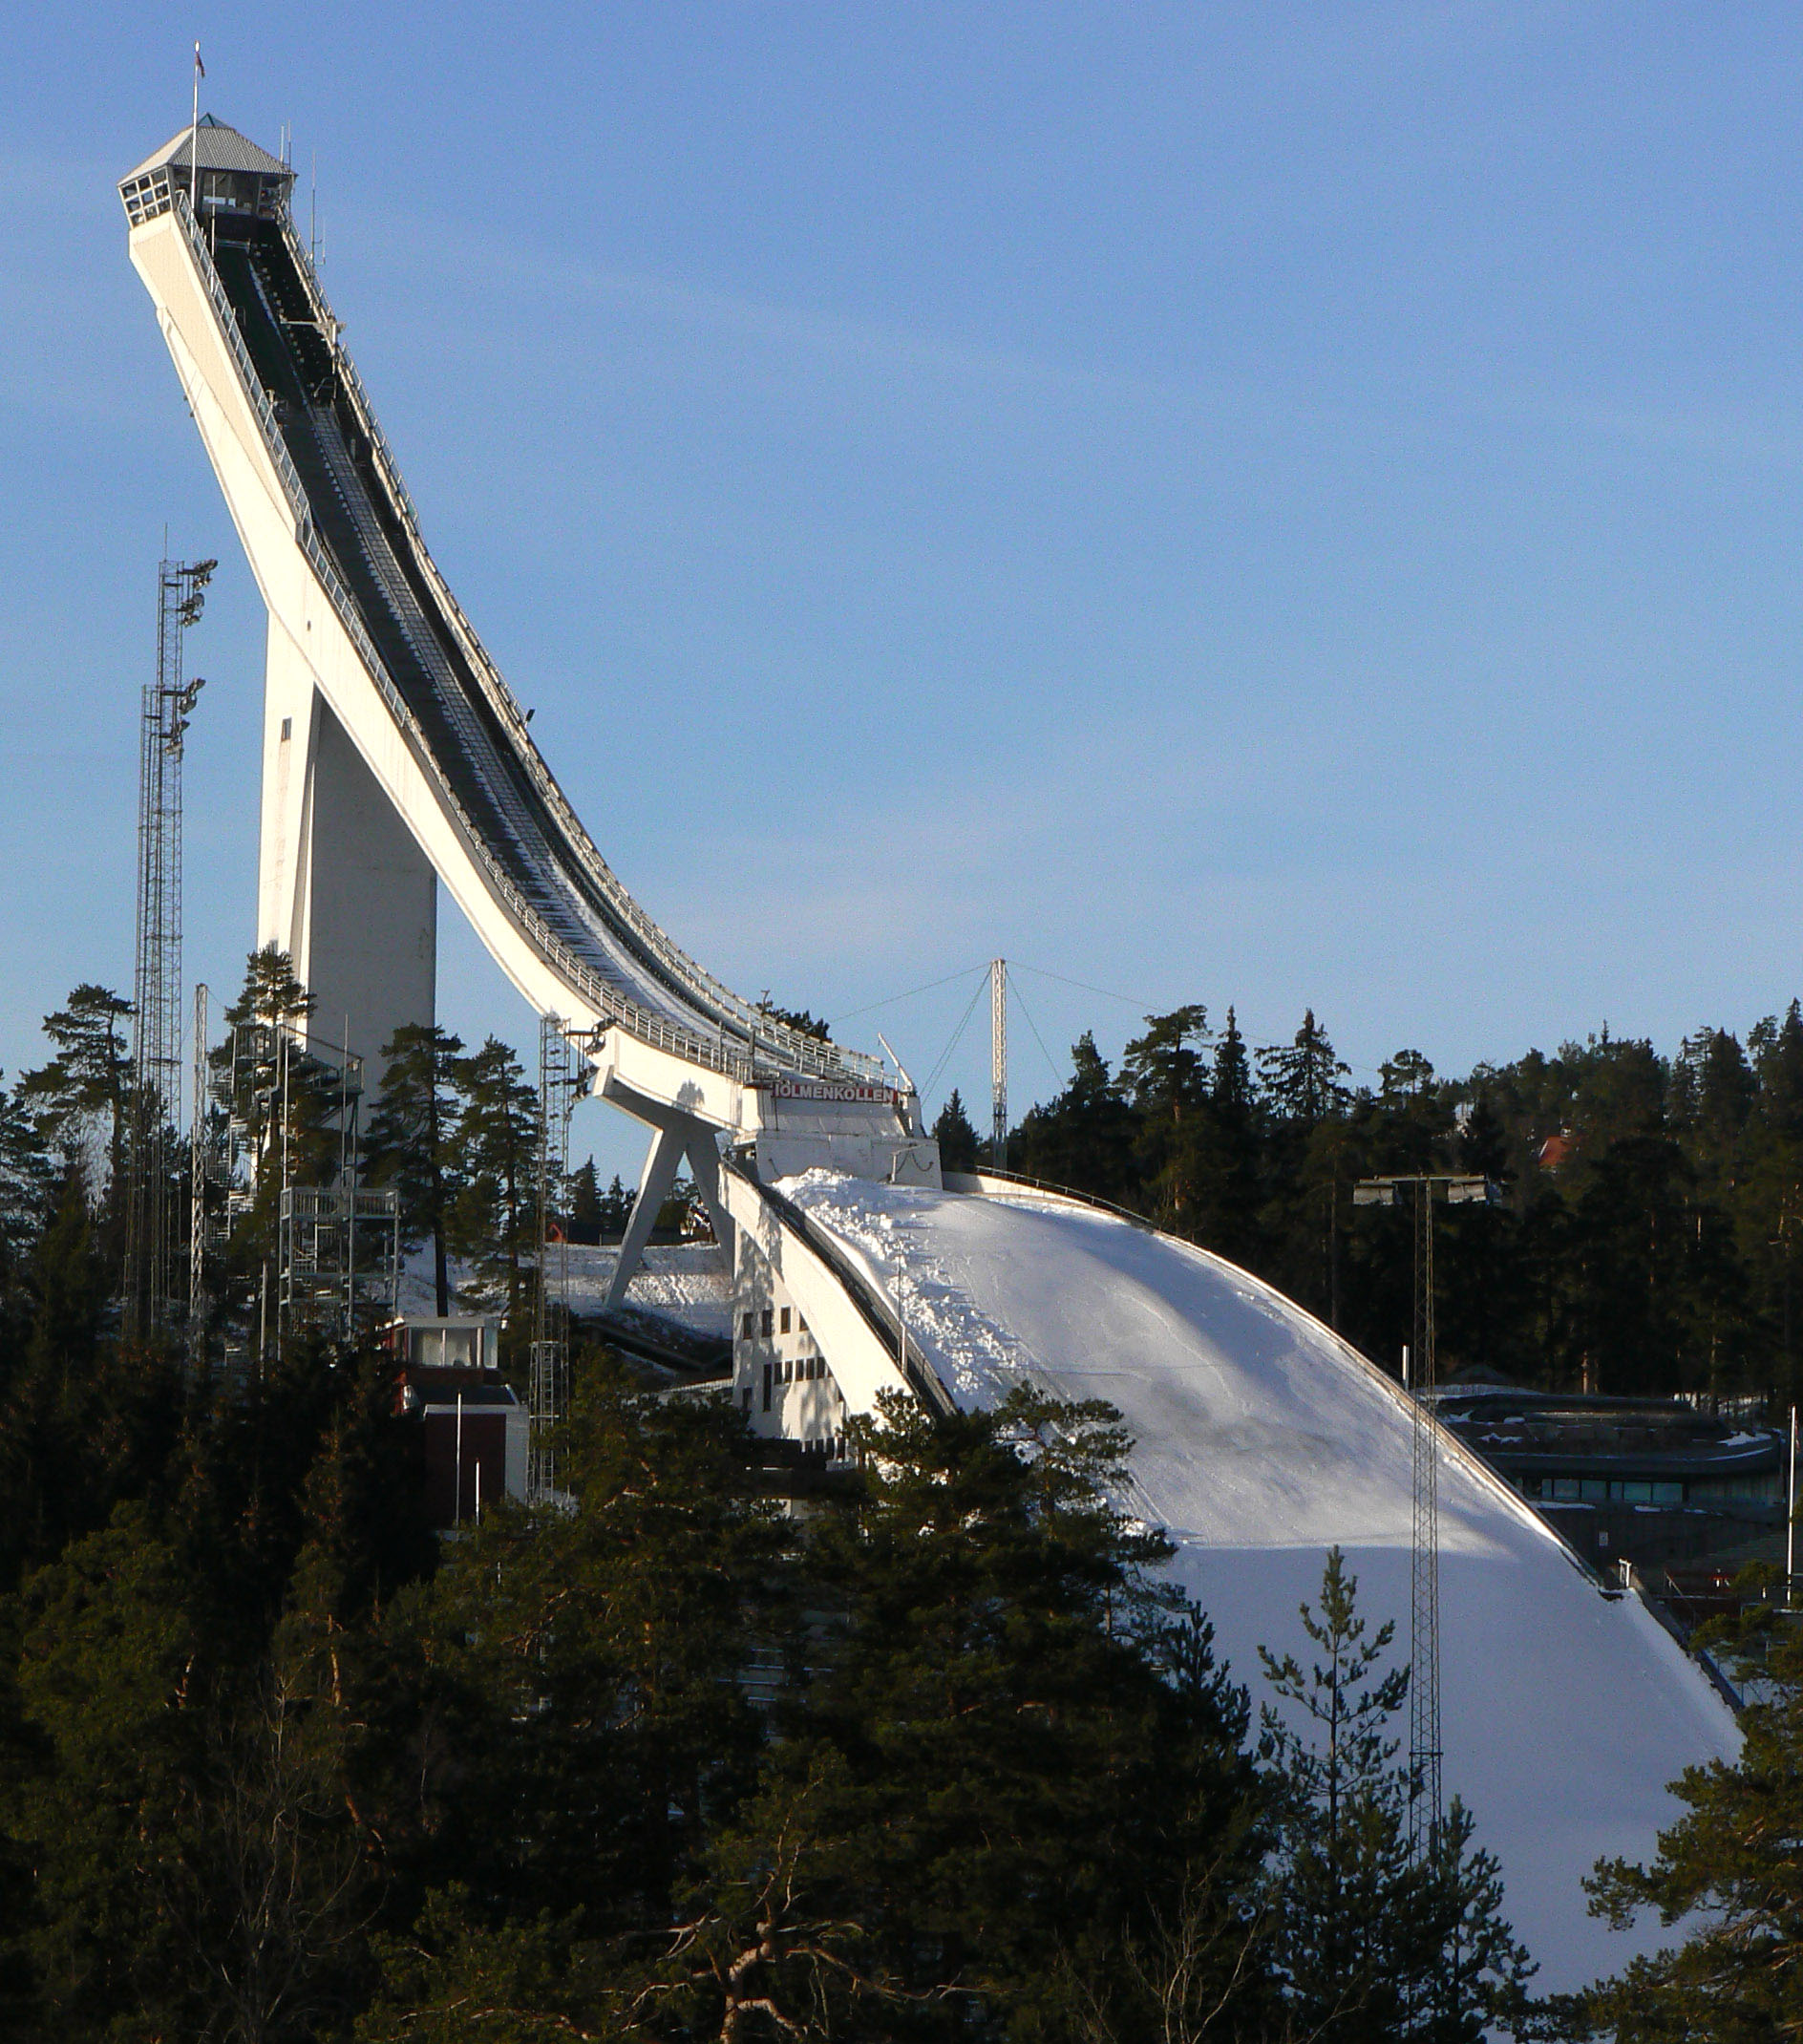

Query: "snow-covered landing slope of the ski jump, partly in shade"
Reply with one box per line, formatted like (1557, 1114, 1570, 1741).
(783, 1171, 1738, 1989)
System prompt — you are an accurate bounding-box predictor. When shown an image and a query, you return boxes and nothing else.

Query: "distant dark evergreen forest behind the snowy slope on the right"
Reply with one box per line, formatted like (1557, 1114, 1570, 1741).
(939, 1002, 1803, 1404)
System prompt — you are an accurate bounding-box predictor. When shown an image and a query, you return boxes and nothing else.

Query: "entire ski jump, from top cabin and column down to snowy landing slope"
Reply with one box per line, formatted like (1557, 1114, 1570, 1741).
(120, 120, 1735, 1987)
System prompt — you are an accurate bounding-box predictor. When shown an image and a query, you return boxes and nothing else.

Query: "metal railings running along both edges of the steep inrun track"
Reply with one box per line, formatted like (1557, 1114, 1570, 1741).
(147, 178, 885, 1083)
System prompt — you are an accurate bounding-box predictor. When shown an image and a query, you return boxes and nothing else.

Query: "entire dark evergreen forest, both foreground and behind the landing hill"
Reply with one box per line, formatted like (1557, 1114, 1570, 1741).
(0, 952, 1803, 2044)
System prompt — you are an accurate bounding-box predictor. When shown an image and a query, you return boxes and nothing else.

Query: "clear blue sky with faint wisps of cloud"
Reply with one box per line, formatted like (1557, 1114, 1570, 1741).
(0, 0, 1803, 1155)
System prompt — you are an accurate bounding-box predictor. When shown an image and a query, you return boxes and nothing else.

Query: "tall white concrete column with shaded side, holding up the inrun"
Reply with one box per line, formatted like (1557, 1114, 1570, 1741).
(258, 615, 437, 1092)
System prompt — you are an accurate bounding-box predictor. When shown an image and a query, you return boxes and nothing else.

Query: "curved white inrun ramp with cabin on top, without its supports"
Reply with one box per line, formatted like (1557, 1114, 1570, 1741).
(120, 122, 936, 1180)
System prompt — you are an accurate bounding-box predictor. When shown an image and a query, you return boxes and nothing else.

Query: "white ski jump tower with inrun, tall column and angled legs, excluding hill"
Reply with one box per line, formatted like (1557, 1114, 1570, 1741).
(118, 117, 939, 1289)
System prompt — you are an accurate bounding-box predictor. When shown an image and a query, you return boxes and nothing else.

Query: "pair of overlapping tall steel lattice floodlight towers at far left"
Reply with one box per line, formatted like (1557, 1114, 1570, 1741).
(122, 560, 217, 1339)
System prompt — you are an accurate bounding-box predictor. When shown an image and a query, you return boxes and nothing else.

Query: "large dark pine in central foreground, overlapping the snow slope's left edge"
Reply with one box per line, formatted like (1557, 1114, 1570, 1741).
(732, 1392, 1260, 2038)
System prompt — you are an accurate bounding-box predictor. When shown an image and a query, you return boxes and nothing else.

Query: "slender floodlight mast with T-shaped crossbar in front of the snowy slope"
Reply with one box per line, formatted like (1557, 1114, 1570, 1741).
(1353, 1171, 1502, 1858)
